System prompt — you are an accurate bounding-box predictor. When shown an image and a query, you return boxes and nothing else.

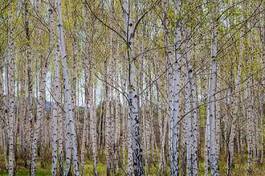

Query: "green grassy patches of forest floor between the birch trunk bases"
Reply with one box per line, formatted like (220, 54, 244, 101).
(0, 154, 265, 176)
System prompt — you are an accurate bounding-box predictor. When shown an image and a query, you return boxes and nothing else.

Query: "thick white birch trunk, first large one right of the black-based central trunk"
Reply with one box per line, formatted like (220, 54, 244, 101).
(168, 0, 181, 176)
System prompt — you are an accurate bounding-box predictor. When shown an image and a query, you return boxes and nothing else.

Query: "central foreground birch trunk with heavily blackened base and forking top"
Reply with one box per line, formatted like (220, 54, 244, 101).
(122, 0, 144, 176)
